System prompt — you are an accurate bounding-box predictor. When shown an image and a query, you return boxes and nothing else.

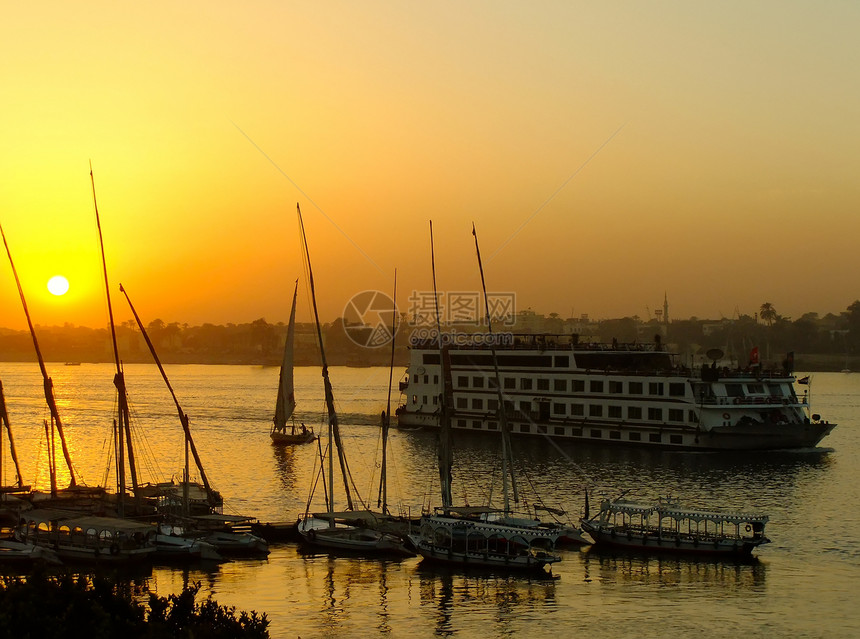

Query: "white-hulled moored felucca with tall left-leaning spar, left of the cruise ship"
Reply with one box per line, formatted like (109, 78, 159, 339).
(296, 204, 414, 555)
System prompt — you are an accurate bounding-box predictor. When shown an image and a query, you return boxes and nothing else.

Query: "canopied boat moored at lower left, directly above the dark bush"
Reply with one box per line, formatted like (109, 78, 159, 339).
(15, 508, 156, 563)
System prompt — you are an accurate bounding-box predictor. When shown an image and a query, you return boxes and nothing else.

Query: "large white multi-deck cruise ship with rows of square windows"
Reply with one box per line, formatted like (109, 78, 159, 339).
(397, 333, 836, 450)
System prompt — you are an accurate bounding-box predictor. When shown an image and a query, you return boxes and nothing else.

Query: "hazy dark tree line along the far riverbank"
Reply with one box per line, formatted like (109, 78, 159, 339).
(0, 300, 860, 370)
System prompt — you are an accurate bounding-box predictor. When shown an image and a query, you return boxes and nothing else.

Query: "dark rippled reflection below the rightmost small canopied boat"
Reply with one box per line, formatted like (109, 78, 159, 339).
(580, 547, 767, 597)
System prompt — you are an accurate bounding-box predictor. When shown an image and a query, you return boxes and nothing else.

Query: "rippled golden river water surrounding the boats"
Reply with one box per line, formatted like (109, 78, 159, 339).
(0, 363, 860, 639)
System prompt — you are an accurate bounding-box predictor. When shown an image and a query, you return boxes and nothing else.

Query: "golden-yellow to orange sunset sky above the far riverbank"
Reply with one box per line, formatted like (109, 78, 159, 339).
(0, 0, 860, 329)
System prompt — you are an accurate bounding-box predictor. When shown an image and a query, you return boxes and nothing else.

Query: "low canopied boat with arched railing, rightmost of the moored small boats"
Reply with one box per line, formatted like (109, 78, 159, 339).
(582, 499, 770, 556)
